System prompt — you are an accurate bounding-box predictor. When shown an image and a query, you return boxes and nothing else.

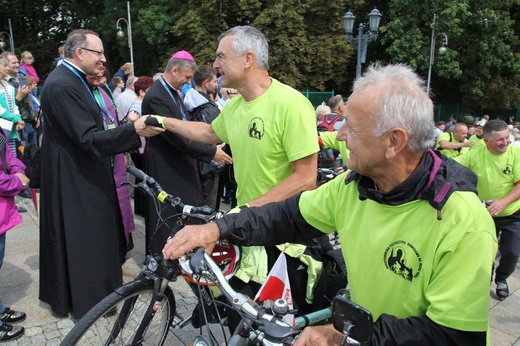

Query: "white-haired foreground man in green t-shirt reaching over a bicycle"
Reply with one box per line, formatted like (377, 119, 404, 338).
(163, 64, 497, 346)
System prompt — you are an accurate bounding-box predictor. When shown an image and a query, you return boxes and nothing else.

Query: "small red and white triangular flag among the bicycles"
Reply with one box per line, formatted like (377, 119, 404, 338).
(255, 252, 295, 326)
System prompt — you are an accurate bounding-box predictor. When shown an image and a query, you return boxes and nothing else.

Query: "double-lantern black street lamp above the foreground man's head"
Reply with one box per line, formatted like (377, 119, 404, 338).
(343, 7, 382, 79)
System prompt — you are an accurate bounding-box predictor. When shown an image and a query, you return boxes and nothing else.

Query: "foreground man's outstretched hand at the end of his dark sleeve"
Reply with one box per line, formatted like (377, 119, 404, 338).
(162, 223, 220, 259)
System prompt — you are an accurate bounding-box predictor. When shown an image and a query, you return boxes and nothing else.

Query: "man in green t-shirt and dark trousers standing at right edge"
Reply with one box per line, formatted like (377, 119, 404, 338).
(455, 119, 520, 300)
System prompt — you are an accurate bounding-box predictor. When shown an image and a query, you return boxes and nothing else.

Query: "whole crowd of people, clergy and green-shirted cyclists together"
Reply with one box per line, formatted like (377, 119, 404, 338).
(0, 26, 520, 346)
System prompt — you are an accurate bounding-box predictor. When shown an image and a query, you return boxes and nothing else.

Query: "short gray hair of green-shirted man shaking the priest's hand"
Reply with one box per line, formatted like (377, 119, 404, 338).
(218, 26, 269, 71)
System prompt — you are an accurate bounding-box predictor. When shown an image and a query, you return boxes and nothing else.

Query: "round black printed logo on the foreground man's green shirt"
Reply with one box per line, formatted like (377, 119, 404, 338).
(384, 240, 422, 281)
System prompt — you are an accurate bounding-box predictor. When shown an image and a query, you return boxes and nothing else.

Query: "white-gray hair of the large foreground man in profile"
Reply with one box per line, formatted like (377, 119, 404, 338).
(354, 63, 434, 153)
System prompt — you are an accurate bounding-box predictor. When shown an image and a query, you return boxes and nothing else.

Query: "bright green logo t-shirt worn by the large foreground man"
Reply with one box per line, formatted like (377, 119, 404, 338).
(299, 173, 497, 331)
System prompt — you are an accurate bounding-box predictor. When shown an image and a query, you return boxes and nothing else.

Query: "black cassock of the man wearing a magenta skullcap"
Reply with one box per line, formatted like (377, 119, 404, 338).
(142, 80, 216, 253)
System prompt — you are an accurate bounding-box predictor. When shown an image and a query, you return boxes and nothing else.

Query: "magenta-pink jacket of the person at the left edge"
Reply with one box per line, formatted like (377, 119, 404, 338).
(0, 129, 25, 234)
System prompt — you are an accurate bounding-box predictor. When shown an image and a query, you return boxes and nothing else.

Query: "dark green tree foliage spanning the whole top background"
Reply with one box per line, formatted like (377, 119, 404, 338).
(0, 0, 520, 109)
